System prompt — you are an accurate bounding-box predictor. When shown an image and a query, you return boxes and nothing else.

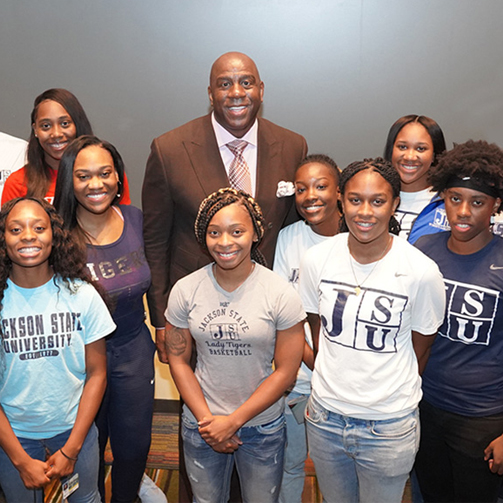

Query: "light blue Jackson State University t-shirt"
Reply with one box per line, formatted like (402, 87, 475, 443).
(0, 278, 115, 439)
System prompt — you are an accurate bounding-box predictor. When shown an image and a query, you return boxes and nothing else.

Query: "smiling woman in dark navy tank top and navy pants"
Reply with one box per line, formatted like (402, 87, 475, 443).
(54, 136, 155, 501)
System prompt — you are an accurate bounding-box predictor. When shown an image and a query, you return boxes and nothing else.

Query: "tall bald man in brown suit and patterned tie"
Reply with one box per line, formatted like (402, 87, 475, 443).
(142, 52, 307, 501)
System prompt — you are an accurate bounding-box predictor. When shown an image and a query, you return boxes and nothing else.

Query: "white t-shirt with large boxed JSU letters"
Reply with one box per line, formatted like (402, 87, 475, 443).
(299, 233, 445, 420)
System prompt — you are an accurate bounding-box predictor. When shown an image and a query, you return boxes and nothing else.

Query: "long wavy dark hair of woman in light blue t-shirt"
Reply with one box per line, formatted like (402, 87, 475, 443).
(0, 197, 91, 322)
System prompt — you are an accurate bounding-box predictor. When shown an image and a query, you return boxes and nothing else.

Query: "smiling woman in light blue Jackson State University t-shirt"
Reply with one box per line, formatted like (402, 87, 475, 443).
(0, 198, 115, 503)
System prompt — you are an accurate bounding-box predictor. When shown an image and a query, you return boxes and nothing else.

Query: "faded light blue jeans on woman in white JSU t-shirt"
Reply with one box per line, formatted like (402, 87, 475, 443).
(306, 396, 419, 503)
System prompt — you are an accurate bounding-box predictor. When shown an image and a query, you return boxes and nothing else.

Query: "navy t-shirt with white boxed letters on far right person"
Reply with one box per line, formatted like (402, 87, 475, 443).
(416, 232, 503, 416)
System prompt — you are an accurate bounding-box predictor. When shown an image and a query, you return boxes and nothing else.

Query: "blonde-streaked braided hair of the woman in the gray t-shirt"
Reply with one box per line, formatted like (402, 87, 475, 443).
(194, 187, 267, 266)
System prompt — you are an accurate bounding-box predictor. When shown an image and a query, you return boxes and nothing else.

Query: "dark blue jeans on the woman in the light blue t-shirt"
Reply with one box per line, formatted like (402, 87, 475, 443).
(0, 425, 101, 503)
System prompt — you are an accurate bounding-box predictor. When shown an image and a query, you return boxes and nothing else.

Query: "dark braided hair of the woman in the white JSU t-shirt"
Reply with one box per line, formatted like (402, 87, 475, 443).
(339, 157, 401, 236)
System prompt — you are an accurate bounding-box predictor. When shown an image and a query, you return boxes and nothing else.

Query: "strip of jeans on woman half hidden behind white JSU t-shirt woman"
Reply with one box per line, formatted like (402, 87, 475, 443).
(279, 392, 307, 503)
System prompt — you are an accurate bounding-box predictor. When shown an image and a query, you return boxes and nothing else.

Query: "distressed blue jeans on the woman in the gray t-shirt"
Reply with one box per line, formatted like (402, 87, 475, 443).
(182, 415, 286, 503)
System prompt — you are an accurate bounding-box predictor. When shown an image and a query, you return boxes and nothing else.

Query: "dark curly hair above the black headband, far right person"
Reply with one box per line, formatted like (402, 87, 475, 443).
(430, 140, 503, 213)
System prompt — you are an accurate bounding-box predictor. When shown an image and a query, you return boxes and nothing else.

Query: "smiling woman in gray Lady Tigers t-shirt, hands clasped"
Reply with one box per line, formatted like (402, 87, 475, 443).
(166, 188, 305, 503)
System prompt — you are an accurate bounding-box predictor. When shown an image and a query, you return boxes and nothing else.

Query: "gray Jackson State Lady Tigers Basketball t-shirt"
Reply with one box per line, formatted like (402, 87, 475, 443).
(165, 264, 306, 426)
